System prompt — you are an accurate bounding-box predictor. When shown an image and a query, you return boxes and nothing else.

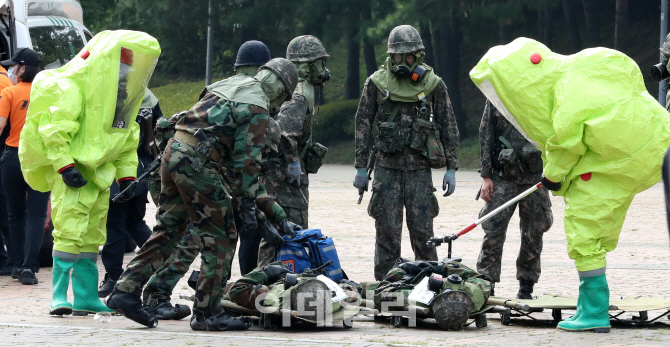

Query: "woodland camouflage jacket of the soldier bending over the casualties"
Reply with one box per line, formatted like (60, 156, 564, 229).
(175, 93, 268, 199)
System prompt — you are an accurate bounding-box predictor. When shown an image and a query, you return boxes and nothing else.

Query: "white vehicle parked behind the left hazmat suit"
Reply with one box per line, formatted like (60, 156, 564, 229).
(0, 0, 93, 69)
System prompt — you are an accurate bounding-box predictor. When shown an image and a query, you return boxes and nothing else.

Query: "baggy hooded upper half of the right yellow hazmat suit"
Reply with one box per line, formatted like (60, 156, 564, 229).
(470, 38, 670, 198)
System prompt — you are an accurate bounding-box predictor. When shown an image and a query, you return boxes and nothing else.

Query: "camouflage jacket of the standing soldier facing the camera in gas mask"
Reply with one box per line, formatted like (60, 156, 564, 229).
(354, 78, 458, 170)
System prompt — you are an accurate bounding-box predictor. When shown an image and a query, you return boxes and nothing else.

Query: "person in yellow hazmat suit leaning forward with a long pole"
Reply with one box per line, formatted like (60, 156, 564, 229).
(470, 38, 670, 332)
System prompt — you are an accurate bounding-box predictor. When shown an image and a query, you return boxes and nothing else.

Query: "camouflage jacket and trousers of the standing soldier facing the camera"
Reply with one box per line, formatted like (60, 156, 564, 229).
(355, 78, 458, 280)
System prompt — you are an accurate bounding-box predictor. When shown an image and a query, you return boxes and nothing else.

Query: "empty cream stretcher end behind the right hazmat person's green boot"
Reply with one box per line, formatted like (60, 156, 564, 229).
(487, 294, 670, 326)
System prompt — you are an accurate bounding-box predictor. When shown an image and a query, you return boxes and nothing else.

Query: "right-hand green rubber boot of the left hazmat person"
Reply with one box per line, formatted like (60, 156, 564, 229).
(72, 258, 114, 316)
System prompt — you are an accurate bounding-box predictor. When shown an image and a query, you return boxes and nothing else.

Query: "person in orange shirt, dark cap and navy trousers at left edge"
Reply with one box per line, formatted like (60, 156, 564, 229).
(0, 48, 49, 284)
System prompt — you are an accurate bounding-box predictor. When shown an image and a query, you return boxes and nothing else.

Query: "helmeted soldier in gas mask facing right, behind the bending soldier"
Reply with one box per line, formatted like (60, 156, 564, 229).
(258, 35, 330, 267)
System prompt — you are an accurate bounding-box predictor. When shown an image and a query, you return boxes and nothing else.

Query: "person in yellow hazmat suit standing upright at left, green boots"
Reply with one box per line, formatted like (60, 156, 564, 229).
(19, 30, 161, 315)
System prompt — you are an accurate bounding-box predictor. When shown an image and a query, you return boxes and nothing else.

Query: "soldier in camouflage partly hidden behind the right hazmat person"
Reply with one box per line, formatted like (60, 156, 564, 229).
(477, 101, 554, 299)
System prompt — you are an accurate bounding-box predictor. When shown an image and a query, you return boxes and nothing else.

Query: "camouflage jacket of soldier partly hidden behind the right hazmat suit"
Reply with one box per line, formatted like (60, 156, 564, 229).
(479, 101, 542, 184)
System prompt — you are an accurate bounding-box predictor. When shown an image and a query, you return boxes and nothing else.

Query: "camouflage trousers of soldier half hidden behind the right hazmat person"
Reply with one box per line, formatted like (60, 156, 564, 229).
(477, 174, 554, 283)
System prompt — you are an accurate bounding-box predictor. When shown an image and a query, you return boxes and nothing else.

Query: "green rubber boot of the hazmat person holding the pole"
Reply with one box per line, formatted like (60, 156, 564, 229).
(558, 274, 611, 333)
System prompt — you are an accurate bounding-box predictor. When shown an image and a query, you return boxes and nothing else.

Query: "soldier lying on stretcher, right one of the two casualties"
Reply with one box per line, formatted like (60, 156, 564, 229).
(358, 258, 491, 330)
